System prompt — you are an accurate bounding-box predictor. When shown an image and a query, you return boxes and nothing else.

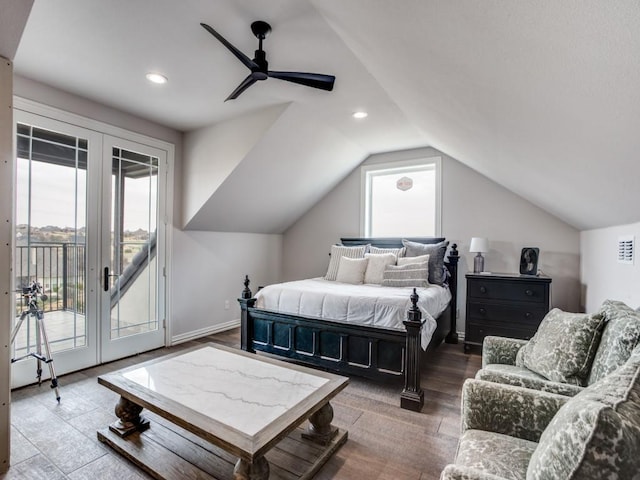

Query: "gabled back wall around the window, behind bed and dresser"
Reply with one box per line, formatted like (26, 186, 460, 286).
(283, 148, 580, 331)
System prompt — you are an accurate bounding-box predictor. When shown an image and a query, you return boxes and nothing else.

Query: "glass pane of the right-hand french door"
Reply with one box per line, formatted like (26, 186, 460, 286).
(110, 147, 158, 339)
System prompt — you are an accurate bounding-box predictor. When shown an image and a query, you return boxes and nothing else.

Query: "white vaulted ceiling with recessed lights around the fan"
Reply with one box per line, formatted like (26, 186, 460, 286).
(5, 0, 640, 232)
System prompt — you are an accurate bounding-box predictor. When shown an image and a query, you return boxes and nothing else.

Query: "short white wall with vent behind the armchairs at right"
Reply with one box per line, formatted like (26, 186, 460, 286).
(580, 223, 640, 312)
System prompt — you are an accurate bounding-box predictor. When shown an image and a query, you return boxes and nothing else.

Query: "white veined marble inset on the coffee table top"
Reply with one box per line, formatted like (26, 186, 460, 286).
(123, 346, 329, 435)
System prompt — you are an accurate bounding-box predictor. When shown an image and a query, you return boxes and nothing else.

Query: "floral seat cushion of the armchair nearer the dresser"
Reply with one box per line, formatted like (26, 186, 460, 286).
(476, 363, 583, 397)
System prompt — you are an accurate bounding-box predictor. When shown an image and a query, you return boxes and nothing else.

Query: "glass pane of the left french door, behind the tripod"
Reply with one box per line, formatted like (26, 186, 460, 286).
(13, 124, 88, 357)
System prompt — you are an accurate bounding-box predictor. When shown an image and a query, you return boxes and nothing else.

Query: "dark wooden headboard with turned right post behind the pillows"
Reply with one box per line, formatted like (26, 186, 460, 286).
(340, 237, 460, 343)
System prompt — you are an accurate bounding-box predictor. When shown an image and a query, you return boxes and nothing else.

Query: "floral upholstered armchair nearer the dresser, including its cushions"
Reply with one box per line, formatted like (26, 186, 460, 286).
(476, 300, 640, 396)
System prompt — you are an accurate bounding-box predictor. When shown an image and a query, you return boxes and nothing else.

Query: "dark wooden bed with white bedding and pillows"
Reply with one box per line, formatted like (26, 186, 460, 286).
(238, 237, 459, 411)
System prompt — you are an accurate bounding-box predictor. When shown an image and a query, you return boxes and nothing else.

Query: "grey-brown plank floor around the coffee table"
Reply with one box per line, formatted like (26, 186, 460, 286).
(2, 330, 481, 480)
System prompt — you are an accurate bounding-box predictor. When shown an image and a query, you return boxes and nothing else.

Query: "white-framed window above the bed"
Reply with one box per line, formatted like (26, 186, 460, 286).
(361, 157, 441, 237)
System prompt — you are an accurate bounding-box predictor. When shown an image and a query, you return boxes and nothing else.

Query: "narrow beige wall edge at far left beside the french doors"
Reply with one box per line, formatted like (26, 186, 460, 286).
(0, 57, 14, 474)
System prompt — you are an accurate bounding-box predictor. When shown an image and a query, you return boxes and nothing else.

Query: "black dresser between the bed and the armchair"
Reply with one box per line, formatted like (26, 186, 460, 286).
(464, 273, 551, 352)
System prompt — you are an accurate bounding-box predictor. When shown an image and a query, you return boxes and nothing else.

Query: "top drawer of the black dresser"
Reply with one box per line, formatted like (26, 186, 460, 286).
(467, 279, 549, 306)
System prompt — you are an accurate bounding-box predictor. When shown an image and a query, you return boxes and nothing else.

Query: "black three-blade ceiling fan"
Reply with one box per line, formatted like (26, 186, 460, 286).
(200, 20, 336, 102)
